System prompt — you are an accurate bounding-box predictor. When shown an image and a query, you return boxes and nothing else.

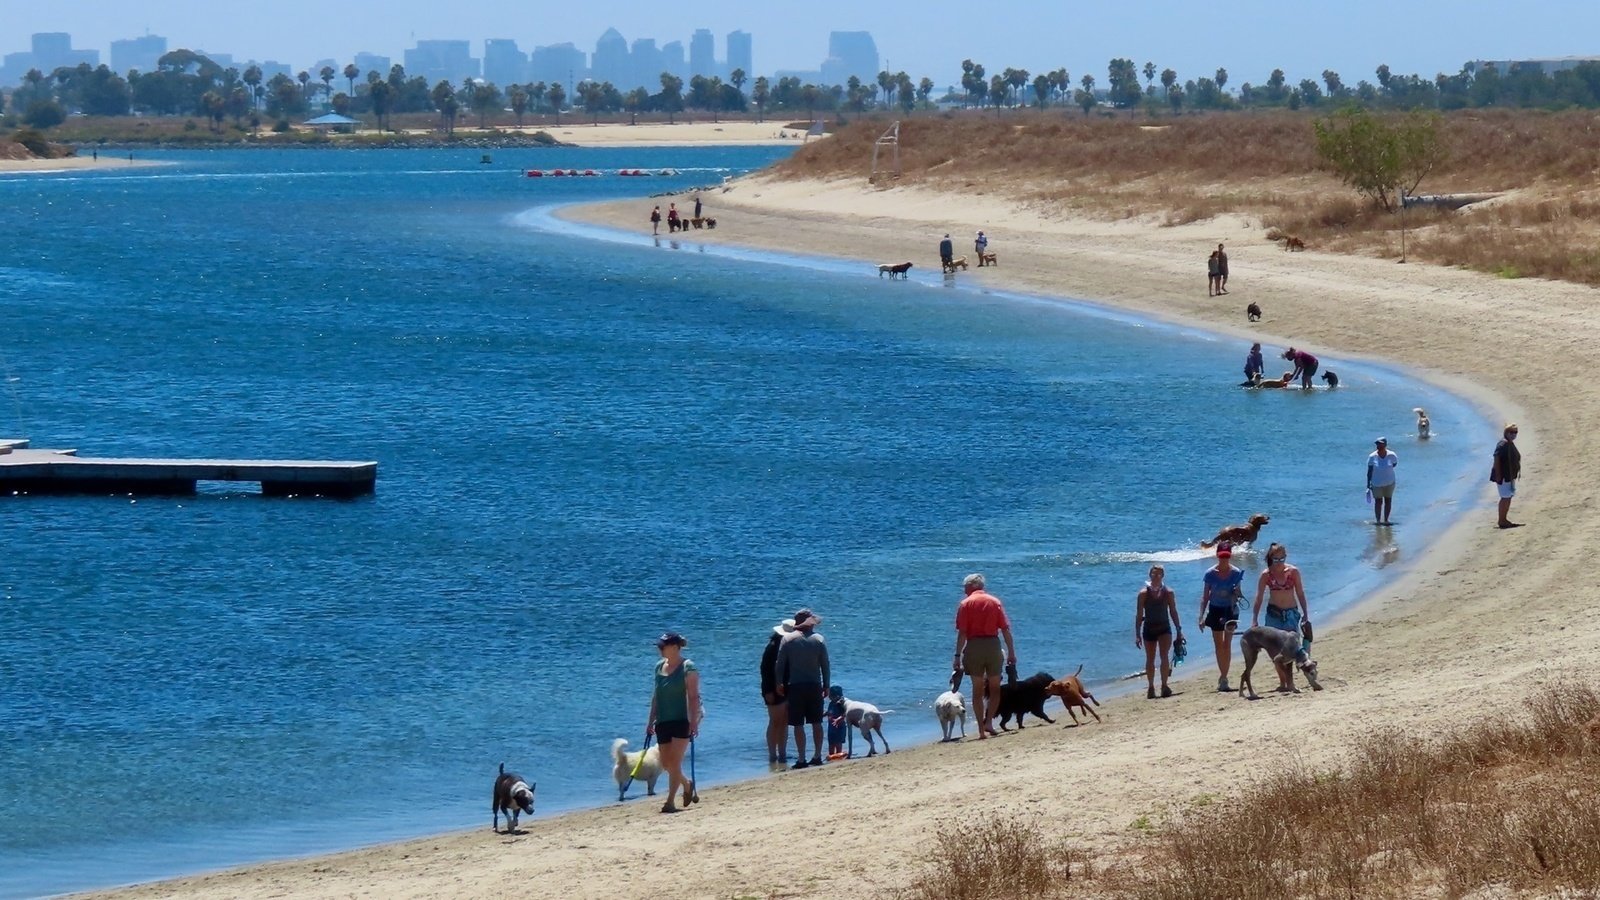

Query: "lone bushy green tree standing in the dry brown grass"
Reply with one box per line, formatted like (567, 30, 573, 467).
(1314, 106, 1446, 211)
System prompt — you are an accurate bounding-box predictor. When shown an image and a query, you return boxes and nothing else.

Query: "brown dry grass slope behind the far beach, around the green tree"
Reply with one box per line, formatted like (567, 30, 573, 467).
(778, 110, 1600, 285)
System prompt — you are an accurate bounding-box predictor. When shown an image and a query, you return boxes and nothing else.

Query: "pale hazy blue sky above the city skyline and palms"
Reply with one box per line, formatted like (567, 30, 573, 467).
(0, 0, 1600, 86)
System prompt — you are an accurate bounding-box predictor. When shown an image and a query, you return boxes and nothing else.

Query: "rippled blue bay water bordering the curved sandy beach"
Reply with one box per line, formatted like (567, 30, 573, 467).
(0, 149, 1491, 897)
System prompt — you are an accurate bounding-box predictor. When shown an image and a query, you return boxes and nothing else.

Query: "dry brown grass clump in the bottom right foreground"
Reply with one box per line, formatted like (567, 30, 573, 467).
(904, 684, 1600, 900)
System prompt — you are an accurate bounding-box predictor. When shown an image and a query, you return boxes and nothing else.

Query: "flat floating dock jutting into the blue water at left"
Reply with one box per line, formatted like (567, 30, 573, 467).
(0, 439, 378, 496)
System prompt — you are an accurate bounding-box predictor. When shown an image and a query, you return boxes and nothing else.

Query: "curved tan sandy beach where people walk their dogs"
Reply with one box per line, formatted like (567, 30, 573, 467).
(87, 169, 1600, 897)
